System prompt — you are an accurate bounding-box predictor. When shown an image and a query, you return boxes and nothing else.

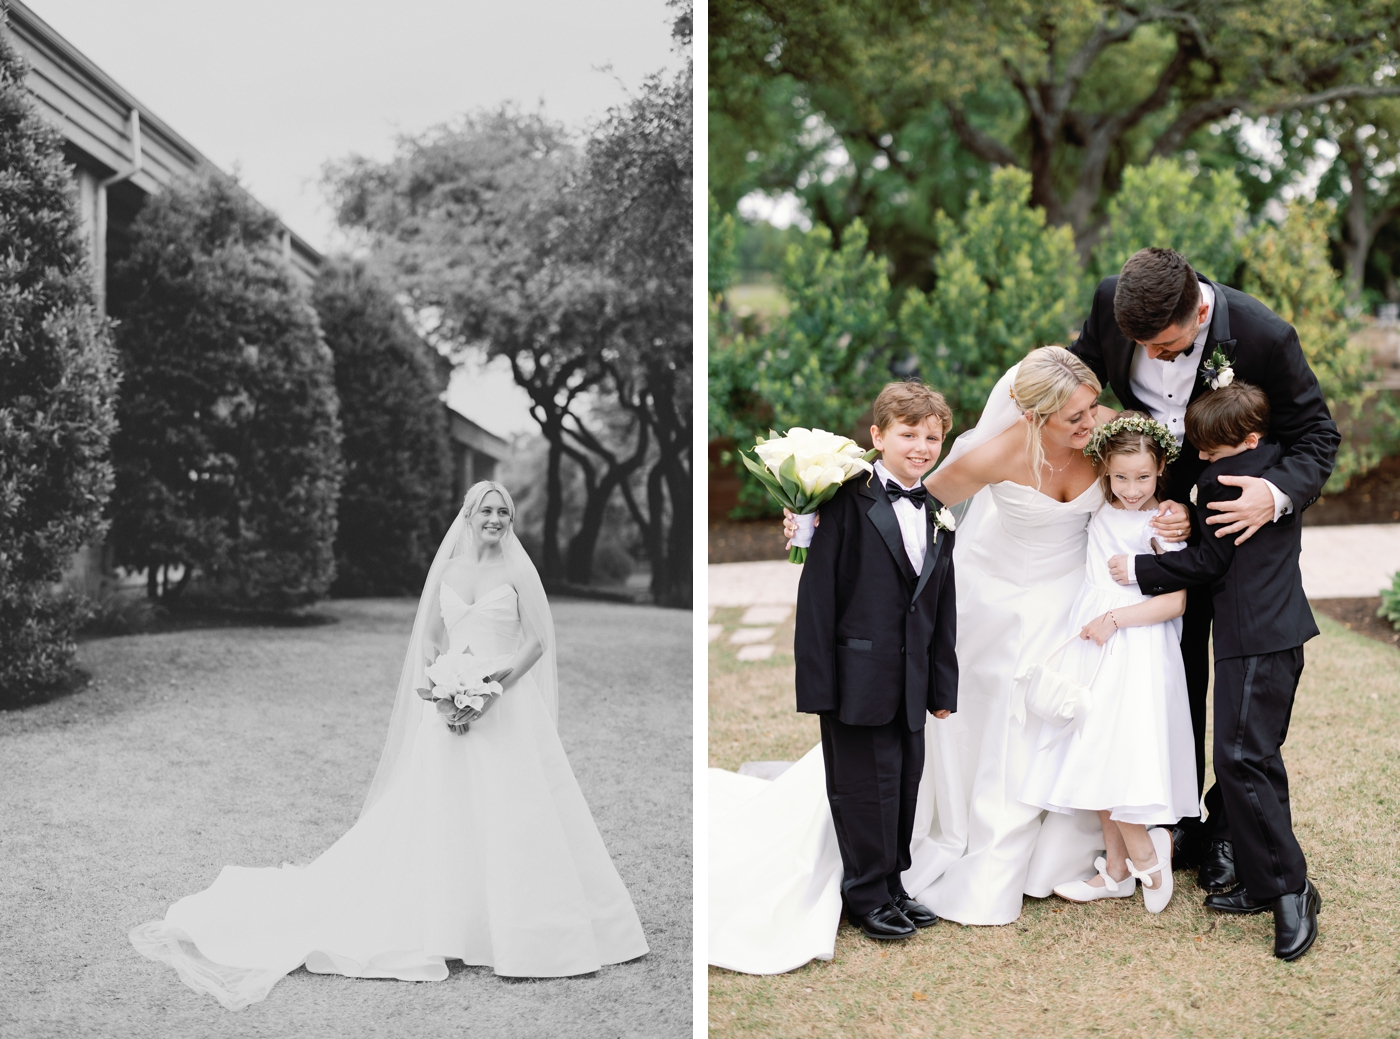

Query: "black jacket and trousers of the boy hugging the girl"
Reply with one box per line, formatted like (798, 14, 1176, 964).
(1134, 441, 1317, 902)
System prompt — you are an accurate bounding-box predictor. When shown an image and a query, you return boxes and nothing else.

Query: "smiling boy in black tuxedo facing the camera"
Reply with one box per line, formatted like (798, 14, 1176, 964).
(795, 382, 958, 938)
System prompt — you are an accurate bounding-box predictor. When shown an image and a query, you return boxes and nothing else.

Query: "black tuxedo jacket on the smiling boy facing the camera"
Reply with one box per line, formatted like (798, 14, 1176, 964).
(794, 475, 958, 732)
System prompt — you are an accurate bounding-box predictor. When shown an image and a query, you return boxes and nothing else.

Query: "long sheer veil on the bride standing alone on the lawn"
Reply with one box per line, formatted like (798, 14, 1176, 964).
(360, 480, 559, 818)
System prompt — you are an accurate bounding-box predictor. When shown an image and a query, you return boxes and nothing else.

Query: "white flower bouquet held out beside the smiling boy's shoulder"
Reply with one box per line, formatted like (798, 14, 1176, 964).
(739, 426, 879, 563)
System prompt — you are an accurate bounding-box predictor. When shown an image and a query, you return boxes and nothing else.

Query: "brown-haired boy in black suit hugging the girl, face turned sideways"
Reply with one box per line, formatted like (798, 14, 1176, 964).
(1109, 382, 1322, 959)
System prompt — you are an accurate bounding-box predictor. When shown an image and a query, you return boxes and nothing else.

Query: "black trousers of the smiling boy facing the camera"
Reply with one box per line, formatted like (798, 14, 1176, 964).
(822, 709, 924, 916)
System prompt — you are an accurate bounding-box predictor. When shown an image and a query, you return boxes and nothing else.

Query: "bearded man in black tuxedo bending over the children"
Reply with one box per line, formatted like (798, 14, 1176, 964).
(1070, 248, 1341, 892)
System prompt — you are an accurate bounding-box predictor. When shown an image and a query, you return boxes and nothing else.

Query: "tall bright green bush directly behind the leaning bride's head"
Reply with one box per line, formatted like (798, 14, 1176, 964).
(899, 168, 1079, 428)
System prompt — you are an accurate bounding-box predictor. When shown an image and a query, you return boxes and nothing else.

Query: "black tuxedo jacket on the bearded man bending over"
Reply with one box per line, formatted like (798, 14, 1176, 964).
(1070, 274, 1341, 509)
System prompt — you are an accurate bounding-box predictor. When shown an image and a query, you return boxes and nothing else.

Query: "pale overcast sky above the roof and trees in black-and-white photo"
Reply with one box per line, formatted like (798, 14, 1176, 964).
(27, 0, 682, 434)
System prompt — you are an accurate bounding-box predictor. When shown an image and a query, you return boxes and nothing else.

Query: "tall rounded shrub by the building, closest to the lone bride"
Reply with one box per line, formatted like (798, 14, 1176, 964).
(312, 260, 452, 595)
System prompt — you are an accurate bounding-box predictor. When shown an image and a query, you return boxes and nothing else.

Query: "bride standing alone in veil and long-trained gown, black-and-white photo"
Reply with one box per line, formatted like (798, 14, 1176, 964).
(130, 482, 647, 1010)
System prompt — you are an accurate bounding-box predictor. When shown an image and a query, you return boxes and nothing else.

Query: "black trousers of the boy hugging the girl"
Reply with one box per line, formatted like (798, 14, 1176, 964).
(1215, 646, 1308, 902)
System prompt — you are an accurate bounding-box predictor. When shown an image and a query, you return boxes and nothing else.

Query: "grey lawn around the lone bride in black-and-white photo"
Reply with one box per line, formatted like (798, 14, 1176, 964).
(0, 599, 692, 1039)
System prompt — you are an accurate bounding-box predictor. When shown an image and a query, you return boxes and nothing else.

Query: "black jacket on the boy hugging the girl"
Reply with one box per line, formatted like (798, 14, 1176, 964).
(1134, 441, 1317, 660)
